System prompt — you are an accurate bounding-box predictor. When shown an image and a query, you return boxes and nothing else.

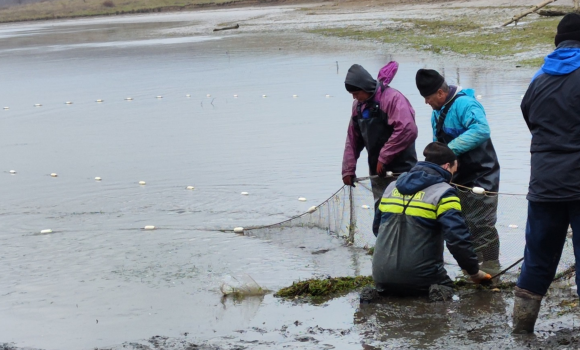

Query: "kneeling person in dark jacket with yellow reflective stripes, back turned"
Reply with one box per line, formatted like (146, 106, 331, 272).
(373, 142, 491, 297)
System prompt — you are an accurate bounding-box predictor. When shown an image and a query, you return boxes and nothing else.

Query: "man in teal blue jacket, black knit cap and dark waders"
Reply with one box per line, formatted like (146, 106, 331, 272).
(415, 69, 500, 266)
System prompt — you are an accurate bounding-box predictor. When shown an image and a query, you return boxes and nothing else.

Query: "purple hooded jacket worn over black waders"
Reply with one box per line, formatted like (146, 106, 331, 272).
(342, 61, 418, 177)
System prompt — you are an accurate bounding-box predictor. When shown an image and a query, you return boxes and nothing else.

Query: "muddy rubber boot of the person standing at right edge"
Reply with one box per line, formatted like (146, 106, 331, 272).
(513, 287, 542, 334)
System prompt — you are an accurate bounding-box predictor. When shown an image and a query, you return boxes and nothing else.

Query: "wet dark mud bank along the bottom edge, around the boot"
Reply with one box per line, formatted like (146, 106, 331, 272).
(81, 289, 580, 350)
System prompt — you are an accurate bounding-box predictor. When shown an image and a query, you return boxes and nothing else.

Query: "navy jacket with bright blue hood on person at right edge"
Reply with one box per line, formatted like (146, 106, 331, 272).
(521, 40, 580, 201)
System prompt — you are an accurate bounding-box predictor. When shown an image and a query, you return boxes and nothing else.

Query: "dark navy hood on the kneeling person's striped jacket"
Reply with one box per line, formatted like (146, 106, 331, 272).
(397, 162, 451, 195)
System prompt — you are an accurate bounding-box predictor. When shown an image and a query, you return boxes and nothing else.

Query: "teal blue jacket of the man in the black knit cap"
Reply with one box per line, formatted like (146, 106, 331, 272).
(431, 89, 490, 156)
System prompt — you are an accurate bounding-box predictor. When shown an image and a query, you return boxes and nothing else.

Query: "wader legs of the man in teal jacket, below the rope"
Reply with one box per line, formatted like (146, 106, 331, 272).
(457, 190, 499, 262)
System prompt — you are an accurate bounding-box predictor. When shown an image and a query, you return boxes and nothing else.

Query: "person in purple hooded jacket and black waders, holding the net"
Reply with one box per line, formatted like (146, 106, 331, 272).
(342, 61, 417, 206)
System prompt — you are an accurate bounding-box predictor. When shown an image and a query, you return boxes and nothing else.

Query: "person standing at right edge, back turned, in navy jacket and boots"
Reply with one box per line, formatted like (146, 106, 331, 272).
(513, 14, 580, 333)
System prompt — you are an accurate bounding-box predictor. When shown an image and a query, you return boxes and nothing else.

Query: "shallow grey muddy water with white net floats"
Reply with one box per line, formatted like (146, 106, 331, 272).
(0, 8, 572, 349)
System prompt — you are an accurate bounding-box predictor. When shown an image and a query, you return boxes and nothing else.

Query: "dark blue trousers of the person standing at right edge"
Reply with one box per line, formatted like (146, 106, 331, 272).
(517, 201, 580, 295)
